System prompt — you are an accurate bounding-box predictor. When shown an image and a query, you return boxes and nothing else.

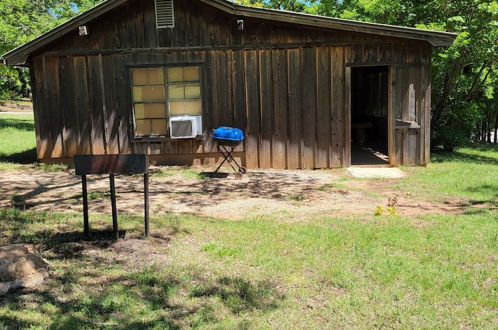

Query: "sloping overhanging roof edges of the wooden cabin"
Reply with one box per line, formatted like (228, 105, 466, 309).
(2, 0, 457, 65)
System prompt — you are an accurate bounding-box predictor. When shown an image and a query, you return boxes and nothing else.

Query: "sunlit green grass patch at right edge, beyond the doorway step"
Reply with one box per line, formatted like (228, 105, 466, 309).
(398, 145, 498, 205)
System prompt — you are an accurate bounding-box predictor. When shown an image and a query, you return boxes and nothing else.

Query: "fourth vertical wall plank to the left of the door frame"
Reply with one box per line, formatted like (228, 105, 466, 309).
(286, 49, 302, 169)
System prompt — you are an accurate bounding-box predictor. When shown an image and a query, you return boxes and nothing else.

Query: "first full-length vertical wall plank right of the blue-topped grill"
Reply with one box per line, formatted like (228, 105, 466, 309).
(244, 50, 260, 168)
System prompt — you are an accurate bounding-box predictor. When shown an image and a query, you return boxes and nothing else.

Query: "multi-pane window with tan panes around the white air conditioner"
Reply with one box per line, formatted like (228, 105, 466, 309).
(131, 66, 202, 137)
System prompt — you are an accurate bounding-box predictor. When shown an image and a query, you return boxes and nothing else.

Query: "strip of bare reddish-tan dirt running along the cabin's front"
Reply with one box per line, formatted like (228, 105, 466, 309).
(0, 169, 466, 221)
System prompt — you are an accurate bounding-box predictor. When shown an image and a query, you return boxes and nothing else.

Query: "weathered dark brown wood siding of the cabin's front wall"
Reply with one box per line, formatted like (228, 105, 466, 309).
(30, 0, 430, 169)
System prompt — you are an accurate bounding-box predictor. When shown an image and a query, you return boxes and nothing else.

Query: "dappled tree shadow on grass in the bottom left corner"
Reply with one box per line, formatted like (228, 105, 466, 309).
(0, 268, 283, 329)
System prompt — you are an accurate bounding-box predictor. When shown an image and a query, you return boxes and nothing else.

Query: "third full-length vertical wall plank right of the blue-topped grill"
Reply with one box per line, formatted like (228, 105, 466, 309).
(272, 49, 288, 169)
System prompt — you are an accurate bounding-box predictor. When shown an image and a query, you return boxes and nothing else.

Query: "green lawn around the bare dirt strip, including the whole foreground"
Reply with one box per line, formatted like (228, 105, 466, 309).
(0, 115, 498, 329)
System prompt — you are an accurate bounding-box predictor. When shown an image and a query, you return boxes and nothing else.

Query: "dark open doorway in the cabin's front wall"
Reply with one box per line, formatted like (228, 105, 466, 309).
(351, 66, 389, 165)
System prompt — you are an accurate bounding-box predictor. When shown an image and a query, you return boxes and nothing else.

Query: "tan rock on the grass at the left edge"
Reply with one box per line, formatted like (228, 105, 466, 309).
(0, 244, 49, 296)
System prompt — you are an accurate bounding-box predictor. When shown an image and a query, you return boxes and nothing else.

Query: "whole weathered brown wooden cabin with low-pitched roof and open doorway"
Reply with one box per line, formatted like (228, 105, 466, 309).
(3, 0, 456, 169)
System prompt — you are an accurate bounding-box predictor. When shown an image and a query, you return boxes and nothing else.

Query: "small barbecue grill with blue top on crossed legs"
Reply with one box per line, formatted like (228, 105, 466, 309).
(213, 126, 246, 173)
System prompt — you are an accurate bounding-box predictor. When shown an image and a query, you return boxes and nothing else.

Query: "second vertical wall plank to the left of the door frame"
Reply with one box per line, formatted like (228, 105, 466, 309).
(315, 47, 332, 168)
